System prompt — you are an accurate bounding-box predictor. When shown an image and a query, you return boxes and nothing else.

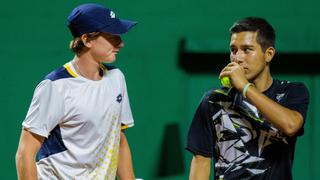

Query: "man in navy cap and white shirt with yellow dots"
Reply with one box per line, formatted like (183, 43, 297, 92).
(16, 4, 136, 180)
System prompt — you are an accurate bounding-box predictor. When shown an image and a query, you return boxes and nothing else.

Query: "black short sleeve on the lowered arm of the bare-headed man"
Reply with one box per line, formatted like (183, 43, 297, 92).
(186, 93, 216, 157)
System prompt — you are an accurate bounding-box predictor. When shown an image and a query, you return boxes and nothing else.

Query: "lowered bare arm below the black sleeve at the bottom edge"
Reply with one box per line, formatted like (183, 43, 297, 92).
(189, 155, 211, 180)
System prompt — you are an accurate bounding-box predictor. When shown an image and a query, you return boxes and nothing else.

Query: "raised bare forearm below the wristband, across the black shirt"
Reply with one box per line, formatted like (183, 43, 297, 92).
(246, 86, 303, 136)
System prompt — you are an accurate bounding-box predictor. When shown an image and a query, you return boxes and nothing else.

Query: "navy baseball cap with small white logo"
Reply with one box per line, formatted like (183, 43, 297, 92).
(67, 3, 137, 37)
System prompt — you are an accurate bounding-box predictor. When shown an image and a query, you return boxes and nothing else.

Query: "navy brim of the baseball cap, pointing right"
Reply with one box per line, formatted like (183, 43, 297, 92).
(101, 19, 138, 35)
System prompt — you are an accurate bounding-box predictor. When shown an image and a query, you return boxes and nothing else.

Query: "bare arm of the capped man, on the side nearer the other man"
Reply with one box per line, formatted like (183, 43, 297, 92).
(117, 131, 135, 180)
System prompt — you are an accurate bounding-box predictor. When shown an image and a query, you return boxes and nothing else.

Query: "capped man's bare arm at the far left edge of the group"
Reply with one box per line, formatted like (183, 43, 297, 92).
(16, 129, 44, 180)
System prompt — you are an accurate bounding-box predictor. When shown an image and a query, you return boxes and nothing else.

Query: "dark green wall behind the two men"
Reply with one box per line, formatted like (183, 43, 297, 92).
(0, 0, 320, 180)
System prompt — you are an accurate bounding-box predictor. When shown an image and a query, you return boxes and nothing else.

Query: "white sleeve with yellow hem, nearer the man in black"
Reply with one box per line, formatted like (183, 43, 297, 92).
(120, 73, 134, 129)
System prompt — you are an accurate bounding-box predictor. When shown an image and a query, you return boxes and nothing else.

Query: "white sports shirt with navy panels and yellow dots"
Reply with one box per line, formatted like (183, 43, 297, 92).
(22, 62, 134, 180)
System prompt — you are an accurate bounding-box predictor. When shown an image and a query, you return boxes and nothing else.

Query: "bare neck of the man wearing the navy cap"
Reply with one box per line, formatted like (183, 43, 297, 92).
(73, 55, 102, 81)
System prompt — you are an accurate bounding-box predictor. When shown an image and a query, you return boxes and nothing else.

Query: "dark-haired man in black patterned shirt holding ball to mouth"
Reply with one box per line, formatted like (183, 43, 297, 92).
(187, 17, 309, 180)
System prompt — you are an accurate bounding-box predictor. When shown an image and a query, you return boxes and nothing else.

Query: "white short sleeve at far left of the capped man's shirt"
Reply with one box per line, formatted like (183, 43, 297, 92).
(22, 79, 64, 137)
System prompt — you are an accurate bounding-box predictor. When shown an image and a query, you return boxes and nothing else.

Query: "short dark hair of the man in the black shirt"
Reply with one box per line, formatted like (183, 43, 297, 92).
(229, 17, 276, 51)
